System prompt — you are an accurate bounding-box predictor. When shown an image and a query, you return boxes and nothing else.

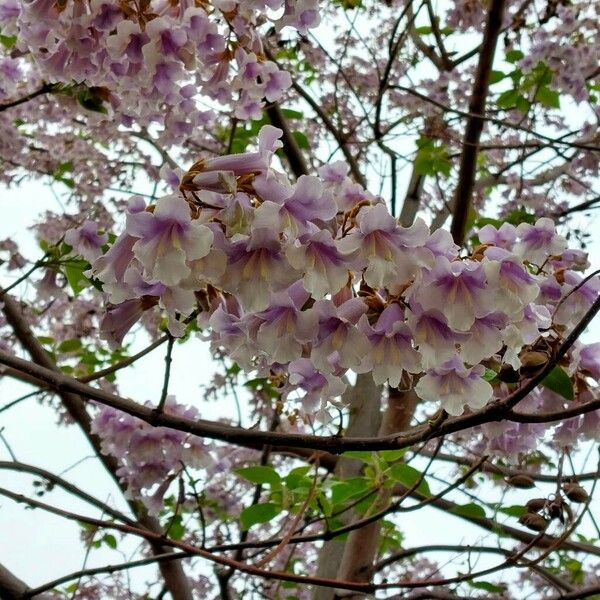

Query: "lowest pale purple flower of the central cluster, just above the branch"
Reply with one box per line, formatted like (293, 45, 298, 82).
(415, 356, 493, 416)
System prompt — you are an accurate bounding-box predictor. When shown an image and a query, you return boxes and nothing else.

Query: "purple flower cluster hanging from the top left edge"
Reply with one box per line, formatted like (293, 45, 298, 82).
(5, 0, 319, 127)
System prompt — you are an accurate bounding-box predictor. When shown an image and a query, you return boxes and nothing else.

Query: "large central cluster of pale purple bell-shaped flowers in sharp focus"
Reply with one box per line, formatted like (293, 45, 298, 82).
(93, 126, 600, 415)
